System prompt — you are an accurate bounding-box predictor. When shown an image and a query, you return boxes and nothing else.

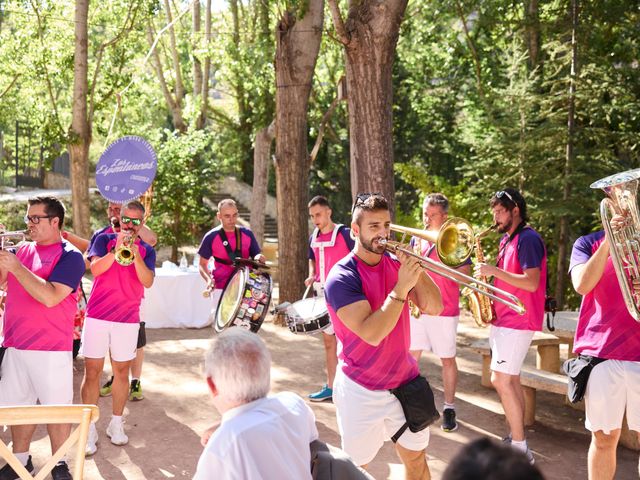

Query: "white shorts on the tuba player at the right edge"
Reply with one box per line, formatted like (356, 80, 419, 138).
(584, 360, 640, 435)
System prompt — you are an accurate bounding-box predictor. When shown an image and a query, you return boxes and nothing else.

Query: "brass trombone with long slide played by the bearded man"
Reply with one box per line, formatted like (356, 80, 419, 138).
(380, 217, 525, 315)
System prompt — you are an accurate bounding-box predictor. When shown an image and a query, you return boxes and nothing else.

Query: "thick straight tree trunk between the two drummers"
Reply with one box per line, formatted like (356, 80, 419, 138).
(275, 0, 324, 302)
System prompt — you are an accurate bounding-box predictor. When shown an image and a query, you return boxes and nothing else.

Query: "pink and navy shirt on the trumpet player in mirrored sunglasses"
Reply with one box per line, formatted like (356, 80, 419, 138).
(87, 233, 156, 323)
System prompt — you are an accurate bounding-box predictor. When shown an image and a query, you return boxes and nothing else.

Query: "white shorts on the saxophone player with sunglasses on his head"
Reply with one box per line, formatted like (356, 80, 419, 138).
(489, 325, 535, 375)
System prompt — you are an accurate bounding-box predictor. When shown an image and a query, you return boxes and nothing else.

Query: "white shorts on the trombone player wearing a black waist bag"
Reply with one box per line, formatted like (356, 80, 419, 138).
(333, 363, 429, 465)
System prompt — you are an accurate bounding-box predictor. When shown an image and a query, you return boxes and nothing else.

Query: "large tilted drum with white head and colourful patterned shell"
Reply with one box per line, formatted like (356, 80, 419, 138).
(213, 266, 273, 333)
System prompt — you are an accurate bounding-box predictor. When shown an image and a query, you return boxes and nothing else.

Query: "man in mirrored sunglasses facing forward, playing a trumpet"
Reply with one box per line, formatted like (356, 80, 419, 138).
(82, 201, 156, 454)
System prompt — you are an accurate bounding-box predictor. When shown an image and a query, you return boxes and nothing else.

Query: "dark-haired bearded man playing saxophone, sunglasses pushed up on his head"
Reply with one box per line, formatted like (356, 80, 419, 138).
(475, 188, 547, 463)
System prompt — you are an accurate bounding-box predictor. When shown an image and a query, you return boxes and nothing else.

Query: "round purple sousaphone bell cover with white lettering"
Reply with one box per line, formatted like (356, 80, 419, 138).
(96, 136, 158, 203)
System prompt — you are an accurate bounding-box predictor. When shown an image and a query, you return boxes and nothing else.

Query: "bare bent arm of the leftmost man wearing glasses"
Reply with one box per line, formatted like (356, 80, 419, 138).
(0, 251, 73, 308)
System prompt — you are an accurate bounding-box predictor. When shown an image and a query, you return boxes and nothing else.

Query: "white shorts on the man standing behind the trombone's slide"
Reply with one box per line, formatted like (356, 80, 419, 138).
(409, 314, 460, 358)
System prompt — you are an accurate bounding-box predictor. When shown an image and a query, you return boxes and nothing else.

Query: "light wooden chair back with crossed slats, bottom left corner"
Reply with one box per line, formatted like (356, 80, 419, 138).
(0, 405, 100, 480)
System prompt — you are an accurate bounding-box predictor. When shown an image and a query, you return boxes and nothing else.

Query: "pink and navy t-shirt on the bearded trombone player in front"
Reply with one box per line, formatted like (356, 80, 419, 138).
(325, 252, 419, 390)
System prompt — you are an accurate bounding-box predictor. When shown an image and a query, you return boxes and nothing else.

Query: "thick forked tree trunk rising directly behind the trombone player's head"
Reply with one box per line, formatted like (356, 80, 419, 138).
(330, 0, 408, 211)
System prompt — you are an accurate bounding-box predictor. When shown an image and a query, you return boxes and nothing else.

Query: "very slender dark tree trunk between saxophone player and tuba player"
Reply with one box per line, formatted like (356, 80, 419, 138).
(555, 0, 578, 308)
